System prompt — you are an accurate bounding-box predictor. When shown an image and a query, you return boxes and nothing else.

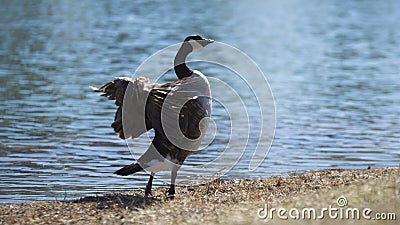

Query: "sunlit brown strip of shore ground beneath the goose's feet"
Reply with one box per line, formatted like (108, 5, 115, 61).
(0, 168, 400, 224)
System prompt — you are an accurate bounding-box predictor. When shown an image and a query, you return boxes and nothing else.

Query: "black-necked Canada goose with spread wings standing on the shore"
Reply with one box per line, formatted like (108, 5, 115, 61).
(94, 35, 214, 199)
